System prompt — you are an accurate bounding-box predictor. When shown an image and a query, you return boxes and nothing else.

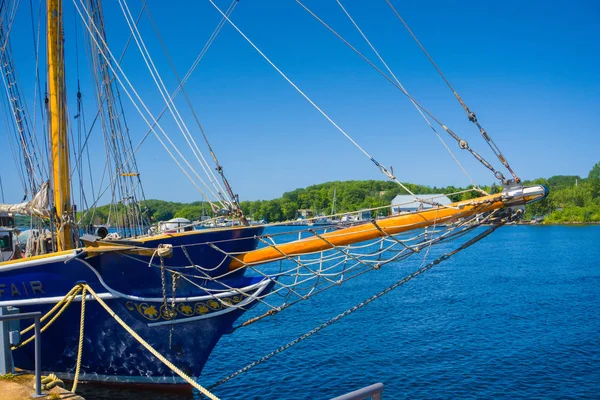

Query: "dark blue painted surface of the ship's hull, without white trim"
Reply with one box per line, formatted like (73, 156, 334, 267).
(0, 228, 272, 377)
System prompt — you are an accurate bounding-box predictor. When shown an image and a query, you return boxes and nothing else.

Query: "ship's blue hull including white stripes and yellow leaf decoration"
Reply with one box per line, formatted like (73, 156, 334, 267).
(0, 228, 274, 383)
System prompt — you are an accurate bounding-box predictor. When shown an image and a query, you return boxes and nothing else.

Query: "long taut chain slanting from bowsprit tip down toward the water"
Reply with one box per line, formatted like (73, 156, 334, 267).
(207, 221, 504, 390)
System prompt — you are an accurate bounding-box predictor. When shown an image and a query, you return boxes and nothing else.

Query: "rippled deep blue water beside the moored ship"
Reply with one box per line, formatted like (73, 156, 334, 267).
(77, 226, 600, 399)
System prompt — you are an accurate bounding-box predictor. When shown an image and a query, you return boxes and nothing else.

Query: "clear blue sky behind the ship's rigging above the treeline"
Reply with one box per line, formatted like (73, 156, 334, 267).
(0, 0, 600, 206)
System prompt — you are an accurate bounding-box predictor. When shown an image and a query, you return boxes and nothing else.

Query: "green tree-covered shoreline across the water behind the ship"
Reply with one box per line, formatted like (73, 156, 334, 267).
(75, 162, 600, 225)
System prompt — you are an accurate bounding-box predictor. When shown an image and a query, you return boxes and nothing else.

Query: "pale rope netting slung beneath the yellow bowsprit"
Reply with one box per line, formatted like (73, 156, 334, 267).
(119, 191, 513, 329)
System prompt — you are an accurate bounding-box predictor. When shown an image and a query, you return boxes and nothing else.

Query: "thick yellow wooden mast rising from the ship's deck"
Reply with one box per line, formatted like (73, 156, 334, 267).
(47, 0, 73, 251)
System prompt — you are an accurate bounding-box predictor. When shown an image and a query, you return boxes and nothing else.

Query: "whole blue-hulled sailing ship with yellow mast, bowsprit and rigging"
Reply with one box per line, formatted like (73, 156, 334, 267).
(0, 0, 547, 390)
